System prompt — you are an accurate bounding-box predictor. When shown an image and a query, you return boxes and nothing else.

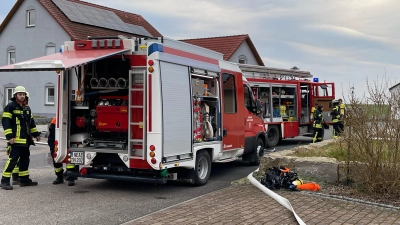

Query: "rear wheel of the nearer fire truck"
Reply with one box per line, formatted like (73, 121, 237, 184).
(192, 150, 211, 186)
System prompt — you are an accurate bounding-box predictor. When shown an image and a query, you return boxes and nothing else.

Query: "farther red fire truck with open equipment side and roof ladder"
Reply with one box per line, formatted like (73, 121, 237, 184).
(239, 64, 335, 147)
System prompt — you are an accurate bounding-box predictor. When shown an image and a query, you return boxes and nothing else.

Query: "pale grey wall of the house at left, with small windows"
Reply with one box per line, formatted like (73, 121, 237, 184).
(0, 0, 71, 117)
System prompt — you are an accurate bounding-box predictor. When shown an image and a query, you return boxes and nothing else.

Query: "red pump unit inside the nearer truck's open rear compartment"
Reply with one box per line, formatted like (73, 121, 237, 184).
(95, 96, 129, 132)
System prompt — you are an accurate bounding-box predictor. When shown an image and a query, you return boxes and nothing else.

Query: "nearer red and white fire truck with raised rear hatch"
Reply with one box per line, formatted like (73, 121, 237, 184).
(0, 36, 267, 185)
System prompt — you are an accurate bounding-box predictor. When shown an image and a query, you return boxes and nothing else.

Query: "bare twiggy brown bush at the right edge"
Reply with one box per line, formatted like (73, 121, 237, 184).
(340, 74, 400, 195)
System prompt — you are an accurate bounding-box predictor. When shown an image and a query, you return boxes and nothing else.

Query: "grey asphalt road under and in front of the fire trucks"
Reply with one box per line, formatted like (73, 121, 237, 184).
(0, 129, 330, 225)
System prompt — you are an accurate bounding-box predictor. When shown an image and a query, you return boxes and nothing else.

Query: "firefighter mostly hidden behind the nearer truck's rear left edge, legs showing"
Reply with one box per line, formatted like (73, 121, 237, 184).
(47, 117, 79, 186)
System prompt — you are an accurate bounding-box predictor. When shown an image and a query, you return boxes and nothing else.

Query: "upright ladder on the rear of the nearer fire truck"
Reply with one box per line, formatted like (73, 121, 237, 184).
(128, 66, 147, 160)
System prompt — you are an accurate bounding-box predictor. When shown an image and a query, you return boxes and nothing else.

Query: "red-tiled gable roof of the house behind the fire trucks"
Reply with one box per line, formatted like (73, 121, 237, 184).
(180, 34, 264, 66)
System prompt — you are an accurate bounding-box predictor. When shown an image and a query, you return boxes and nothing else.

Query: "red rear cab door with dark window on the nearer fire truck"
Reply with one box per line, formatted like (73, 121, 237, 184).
(221, 73, 245, 151)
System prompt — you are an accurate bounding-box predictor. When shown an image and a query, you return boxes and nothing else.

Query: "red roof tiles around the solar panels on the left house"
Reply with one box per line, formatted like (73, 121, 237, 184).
(0, 0, 162, 40)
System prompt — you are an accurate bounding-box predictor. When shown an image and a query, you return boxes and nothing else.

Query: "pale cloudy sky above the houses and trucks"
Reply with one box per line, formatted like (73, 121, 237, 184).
(0, 0, 400, 98)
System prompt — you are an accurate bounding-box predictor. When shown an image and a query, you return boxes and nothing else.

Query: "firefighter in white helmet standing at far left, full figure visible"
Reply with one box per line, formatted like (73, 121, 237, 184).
(1, 86, 40, 190)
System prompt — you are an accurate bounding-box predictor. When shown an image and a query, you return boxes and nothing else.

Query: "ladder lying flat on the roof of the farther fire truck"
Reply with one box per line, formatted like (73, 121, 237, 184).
(237, 64, 313, 80)
